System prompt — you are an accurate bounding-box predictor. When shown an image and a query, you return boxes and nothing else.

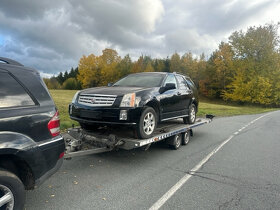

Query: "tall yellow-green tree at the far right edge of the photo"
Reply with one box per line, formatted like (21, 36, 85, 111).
(223, 24, 280, 105)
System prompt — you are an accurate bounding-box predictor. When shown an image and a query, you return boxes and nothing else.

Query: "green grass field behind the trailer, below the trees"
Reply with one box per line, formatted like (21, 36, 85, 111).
(50, 90, 276, 130)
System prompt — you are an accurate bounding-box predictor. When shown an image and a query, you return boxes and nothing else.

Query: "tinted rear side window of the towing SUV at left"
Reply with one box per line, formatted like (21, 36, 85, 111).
(0, 72, 35, 108)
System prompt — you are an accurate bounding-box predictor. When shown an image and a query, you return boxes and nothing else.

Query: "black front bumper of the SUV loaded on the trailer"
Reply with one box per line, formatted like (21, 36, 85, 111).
(69, 104, 142, 125)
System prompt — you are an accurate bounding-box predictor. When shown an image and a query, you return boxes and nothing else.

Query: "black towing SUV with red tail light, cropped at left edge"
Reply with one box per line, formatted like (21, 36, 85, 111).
(0, 57, 65, 209)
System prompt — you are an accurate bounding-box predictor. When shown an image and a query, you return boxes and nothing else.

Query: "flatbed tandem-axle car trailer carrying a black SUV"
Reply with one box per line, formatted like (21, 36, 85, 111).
(62, 115, 214, 159)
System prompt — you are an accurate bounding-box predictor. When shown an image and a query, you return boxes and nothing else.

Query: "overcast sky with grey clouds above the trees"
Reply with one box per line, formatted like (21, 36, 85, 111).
(0, 0, 280, 74)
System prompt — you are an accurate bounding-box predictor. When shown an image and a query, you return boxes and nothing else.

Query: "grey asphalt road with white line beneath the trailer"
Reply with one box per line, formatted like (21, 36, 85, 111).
(25, 111, 280, 210)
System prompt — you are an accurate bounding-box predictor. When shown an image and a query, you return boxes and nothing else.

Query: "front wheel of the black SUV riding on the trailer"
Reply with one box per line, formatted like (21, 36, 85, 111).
(136, 107, 158, 139)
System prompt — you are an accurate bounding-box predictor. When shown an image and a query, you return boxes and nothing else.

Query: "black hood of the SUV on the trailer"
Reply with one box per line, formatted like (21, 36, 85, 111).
(80, 86, 152, 96)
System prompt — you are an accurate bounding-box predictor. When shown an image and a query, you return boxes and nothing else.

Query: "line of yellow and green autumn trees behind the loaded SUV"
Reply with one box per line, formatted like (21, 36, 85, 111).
(45, 24, 280, 106)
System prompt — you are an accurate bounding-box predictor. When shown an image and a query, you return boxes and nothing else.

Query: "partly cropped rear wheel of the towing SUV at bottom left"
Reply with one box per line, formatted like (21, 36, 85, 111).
(0, 169, 25, 210)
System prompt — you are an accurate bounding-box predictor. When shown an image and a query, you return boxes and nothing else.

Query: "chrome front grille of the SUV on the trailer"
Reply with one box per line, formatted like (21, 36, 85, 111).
(78, 94, 117, 106)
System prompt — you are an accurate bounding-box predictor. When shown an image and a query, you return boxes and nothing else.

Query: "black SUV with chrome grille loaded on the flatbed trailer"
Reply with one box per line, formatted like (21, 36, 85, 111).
(69, 72, 198, 138)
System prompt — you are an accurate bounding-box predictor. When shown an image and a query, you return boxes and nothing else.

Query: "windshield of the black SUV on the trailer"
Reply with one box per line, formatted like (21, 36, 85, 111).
(113, 74, 165, 87)
